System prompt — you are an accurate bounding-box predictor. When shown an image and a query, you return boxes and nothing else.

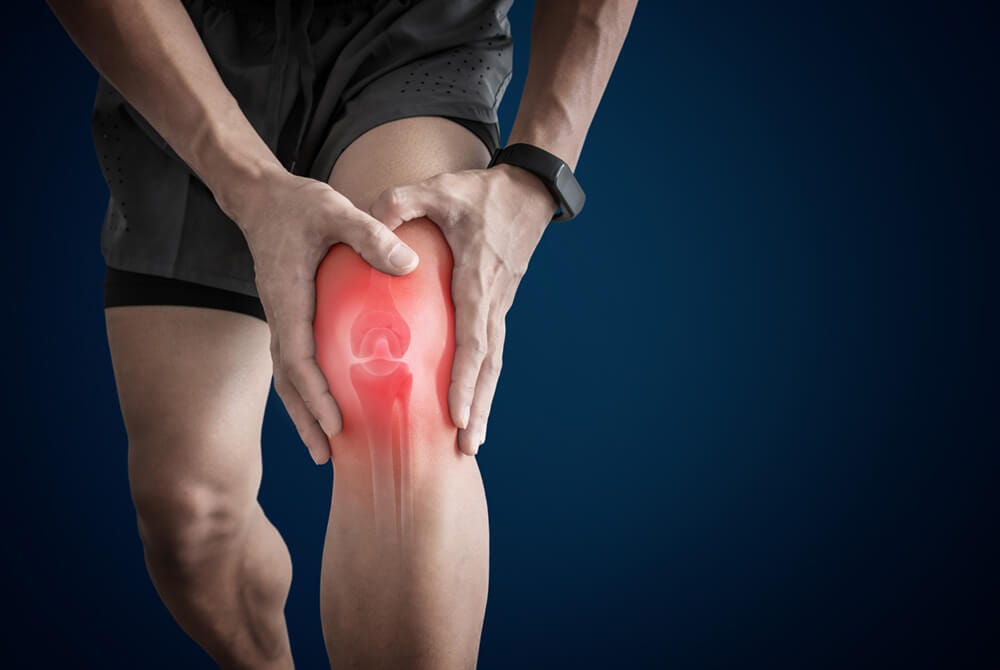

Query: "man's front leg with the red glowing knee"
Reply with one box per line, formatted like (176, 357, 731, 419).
(316, 117, 489, 670)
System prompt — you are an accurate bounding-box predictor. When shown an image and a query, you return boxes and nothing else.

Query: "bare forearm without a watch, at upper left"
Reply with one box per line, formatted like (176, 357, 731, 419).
(49, 0, 282, 215)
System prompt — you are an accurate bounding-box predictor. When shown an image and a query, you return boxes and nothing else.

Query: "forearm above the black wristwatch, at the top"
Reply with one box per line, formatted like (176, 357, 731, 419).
(508, 0, 637, 170)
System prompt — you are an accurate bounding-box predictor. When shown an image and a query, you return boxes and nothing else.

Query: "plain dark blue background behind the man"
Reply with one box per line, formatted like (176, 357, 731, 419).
(0, 0, 1000, 670)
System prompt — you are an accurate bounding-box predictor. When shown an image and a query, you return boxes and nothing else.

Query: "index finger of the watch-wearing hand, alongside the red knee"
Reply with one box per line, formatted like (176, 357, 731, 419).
(448, 268, 489, 428)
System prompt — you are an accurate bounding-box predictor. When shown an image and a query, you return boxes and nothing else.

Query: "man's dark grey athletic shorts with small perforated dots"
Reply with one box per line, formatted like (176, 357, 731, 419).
(91, 0, 513, 318)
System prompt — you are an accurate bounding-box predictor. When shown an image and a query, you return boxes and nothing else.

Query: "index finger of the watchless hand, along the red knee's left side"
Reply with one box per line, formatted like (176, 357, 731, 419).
(275, 272, 341, 437)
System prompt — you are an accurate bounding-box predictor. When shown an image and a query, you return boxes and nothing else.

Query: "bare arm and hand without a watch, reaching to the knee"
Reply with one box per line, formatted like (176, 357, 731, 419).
(49, 0, 417, 463)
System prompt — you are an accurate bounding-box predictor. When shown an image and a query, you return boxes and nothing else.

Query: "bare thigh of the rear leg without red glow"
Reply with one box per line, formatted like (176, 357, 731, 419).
(105, 305, 271, 499)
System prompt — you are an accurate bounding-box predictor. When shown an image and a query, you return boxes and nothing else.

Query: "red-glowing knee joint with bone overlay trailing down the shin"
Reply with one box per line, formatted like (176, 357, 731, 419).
(314, 221, 457, 538)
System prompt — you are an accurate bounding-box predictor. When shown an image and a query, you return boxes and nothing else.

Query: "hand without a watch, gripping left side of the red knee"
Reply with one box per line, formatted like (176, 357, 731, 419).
(230, 169, 418, 465)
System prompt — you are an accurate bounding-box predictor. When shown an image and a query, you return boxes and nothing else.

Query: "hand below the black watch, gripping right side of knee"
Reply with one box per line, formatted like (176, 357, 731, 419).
(370, 164, 558, 456)
